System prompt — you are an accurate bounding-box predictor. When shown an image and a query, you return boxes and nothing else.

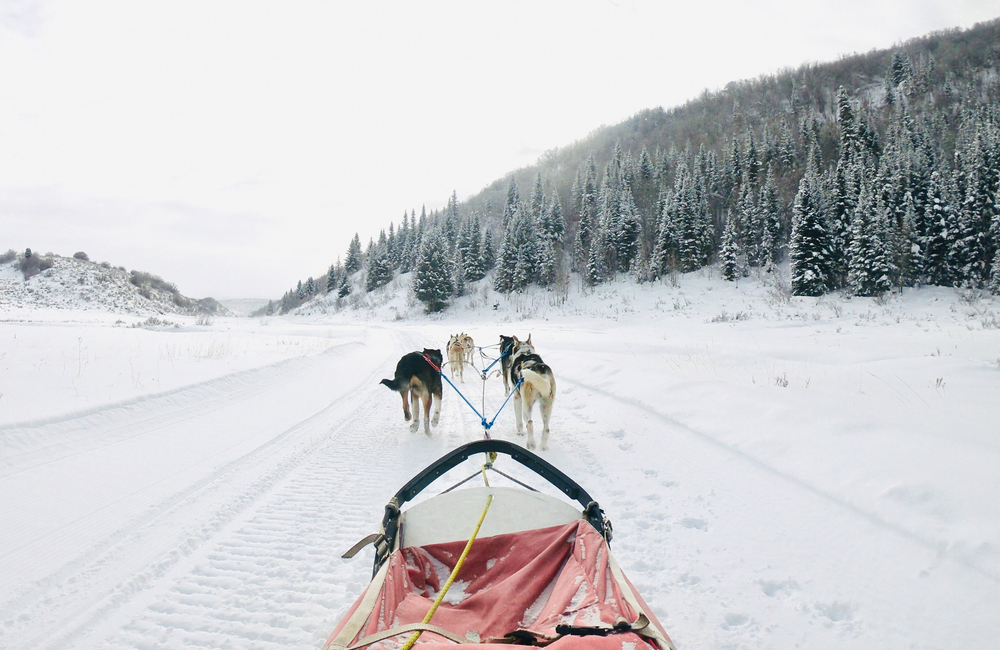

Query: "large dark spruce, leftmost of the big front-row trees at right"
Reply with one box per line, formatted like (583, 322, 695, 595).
(788, 165, 831, 296)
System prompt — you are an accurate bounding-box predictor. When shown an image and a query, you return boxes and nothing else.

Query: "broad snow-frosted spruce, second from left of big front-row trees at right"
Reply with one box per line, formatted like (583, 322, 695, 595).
(848, 180, 896, 296)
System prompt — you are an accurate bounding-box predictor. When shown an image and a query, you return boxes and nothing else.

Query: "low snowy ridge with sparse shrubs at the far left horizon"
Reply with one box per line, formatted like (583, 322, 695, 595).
(0, 254, 228, 315)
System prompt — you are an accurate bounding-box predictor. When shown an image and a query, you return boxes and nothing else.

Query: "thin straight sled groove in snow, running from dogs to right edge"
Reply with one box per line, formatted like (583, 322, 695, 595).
(560, 377, 1000, 584)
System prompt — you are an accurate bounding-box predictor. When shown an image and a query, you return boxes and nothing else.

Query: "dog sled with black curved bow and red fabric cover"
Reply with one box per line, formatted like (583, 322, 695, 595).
(324, 440, 674, 650)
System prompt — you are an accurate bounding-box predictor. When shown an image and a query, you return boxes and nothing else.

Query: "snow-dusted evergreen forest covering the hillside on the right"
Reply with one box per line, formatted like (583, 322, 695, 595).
(267, 20, 1000, 313)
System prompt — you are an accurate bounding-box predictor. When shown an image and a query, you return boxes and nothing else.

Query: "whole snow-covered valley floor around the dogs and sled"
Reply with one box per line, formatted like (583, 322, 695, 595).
(0, 274, 1000, 650)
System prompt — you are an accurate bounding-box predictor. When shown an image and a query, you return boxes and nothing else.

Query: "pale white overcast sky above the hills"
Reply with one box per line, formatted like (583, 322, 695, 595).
(0, 0, 1000, 299)
